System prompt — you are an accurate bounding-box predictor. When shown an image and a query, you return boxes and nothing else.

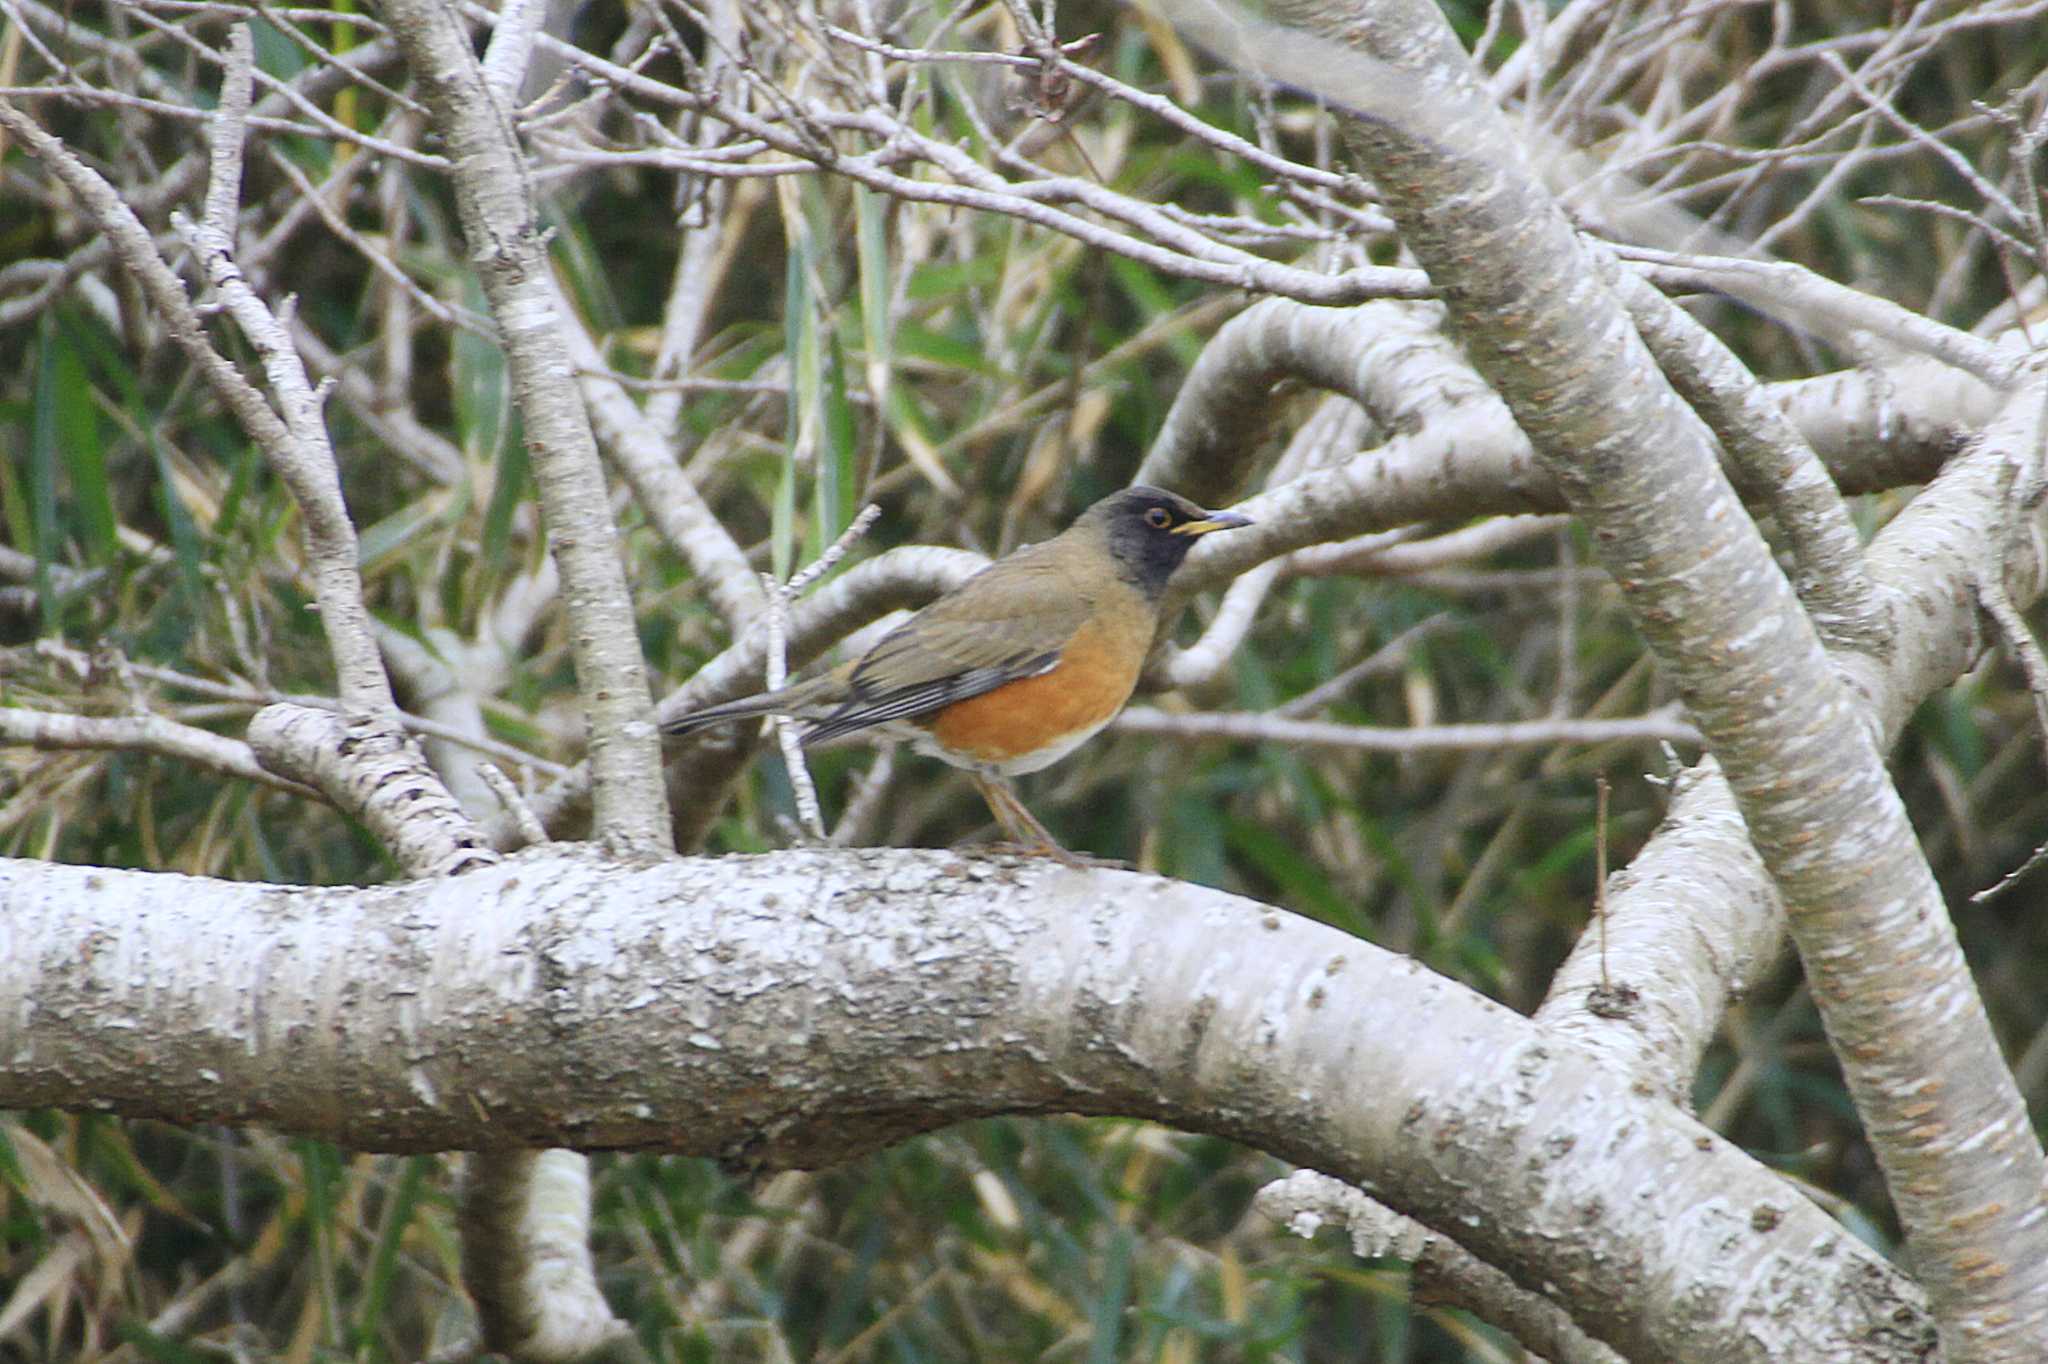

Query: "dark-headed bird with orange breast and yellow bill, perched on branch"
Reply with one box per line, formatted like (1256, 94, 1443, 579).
(662, 483, 1251, 864)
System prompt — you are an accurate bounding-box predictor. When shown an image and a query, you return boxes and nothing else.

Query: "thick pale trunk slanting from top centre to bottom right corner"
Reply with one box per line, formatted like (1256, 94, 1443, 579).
(1247, 0, 2048, 1360)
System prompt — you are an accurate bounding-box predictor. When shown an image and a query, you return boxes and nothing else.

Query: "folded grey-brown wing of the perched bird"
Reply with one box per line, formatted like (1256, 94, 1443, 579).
(803, 545, 1090, 743)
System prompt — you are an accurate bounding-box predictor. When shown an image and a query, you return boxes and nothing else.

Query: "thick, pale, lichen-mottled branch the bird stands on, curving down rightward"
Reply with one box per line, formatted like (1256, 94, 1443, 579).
(0, 850, 1925, 1362)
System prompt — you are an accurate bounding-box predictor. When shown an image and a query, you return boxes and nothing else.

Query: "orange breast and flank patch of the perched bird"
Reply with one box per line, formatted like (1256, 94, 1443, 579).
(922, 619, 1151, 770)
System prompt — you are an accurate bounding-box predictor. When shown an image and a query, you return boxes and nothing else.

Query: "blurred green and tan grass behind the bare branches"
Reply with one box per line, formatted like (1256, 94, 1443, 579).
(0, 2, 2048, 1364)
